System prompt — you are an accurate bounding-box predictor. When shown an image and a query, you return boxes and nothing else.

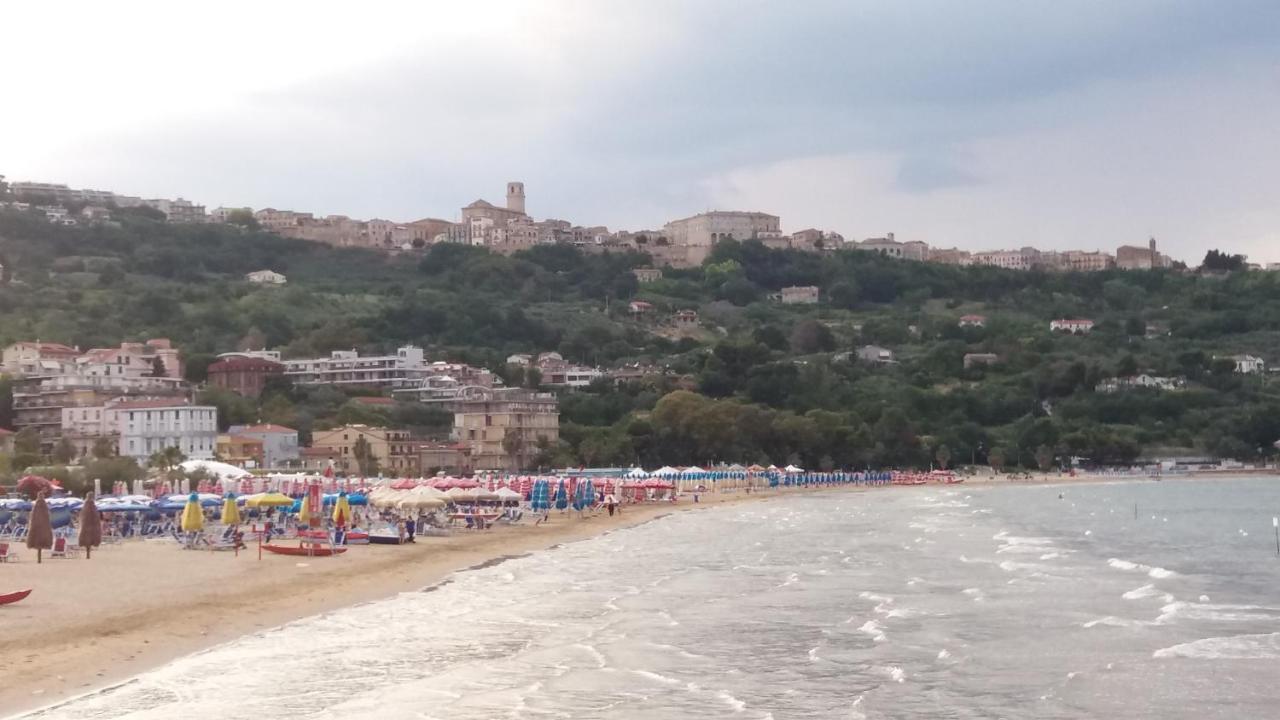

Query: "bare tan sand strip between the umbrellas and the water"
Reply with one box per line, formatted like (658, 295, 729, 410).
(0, 470, 1274, 717)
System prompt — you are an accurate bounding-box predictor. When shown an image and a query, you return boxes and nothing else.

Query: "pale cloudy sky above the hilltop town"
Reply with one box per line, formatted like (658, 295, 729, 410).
(0, 0, 1280, 263)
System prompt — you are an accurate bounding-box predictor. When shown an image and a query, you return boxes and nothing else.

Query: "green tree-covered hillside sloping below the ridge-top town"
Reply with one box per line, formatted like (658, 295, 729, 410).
(0, 204, 1280, 468)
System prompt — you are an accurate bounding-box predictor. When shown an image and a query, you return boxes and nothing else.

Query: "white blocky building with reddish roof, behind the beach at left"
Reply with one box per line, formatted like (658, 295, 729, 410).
(112, 400, 218, 462)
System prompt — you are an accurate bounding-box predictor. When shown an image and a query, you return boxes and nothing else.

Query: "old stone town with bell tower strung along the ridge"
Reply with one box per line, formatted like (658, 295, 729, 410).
(0, 176, 1228, 272)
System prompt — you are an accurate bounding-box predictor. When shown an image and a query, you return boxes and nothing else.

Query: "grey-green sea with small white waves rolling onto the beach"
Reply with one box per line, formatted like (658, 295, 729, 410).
(17, 478, 1280, 720)
